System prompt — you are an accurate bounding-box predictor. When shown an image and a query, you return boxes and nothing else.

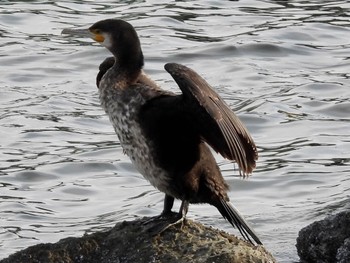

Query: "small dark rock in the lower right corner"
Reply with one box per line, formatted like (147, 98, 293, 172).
(296, 211, 350, 263)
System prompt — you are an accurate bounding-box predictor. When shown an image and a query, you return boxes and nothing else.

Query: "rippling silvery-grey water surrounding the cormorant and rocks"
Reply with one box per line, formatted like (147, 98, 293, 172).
(0, 0, 350, 262)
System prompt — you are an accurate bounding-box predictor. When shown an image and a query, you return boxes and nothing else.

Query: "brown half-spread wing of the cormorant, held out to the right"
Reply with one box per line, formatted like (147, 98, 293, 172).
(164, 63, 258, 176)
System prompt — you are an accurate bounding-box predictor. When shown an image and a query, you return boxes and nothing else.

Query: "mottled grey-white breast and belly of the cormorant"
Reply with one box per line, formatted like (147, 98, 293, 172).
(100, 80, 169, 196)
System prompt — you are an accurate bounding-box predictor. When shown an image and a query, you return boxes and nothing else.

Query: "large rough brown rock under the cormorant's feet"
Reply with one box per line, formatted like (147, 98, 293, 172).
(0, 218, 276, 263)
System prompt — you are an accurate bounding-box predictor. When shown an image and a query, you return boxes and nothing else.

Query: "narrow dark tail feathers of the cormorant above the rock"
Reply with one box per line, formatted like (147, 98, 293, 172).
(218, 199, 262, 245)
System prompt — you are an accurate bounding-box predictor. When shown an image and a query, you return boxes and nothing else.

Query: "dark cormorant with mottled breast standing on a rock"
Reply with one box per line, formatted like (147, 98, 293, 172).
(63, 19, 262, 244)
